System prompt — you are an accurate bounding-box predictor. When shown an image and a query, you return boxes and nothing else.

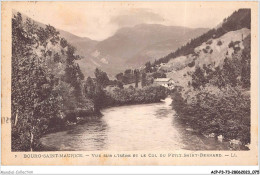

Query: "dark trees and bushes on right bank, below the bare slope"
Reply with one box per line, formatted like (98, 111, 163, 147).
(172, 31, 251, 145)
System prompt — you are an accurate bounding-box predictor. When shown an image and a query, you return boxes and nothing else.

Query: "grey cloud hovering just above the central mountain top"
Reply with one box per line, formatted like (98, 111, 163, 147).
(110, 8, 164, 27)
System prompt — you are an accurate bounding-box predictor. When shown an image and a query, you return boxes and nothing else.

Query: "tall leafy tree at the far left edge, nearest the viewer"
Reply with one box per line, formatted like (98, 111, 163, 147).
(11, 13, 60, 151)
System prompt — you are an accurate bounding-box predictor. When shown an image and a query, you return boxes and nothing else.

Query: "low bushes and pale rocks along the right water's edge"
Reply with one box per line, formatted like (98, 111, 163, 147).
(172, 89, 250, 150)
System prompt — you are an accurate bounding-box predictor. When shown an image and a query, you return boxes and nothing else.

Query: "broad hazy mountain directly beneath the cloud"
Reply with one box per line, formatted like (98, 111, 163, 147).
(92, 24, 208, 66)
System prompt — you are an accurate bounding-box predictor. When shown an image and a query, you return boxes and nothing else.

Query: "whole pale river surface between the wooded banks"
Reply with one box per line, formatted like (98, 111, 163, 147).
(40, 98, 229, 151)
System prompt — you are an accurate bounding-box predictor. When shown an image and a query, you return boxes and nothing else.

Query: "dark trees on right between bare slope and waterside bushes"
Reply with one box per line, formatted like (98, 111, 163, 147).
(191, 35, 251, 89)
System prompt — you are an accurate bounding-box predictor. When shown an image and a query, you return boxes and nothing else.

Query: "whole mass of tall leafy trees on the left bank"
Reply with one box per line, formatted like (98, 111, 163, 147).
(11, 12, 89, 151)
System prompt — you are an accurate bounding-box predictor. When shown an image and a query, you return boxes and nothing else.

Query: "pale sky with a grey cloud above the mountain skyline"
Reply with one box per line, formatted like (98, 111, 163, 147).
(12, 2, 240, 40)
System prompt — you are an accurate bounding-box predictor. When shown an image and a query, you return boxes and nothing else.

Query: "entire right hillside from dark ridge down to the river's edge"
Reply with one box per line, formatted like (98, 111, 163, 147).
(153, 9, 251, 150)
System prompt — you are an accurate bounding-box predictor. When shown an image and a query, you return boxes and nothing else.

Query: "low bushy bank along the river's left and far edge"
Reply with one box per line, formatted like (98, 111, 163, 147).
(37, 86, 168, 151)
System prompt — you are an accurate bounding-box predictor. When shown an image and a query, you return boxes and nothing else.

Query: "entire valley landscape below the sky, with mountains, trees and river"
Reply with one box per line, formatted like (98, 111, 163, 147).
(12, 9, 251, 151)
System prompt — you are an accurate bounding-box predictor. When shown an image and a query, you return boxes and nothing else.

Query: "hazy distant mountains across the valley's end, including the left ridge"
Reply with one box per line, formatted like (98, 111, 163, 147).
(13, 11, 208, 77)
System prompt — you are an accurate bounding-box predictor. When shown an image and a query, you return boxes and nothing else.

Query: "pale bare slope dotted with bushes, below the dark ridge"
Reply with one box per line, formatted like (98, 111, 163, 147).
(164, 28, 250, 87)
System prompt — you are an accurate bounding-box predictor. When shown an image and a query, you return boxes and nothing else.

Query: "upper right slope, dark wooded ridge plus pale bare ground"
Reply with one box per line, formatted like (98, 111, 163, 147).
(150, 9, 251, 89)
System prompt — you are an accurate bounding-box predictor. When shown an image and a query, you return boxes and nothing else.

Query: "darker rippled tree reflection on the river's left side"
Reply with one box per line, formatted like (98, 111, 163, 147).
(41, 118, 107, 151)
